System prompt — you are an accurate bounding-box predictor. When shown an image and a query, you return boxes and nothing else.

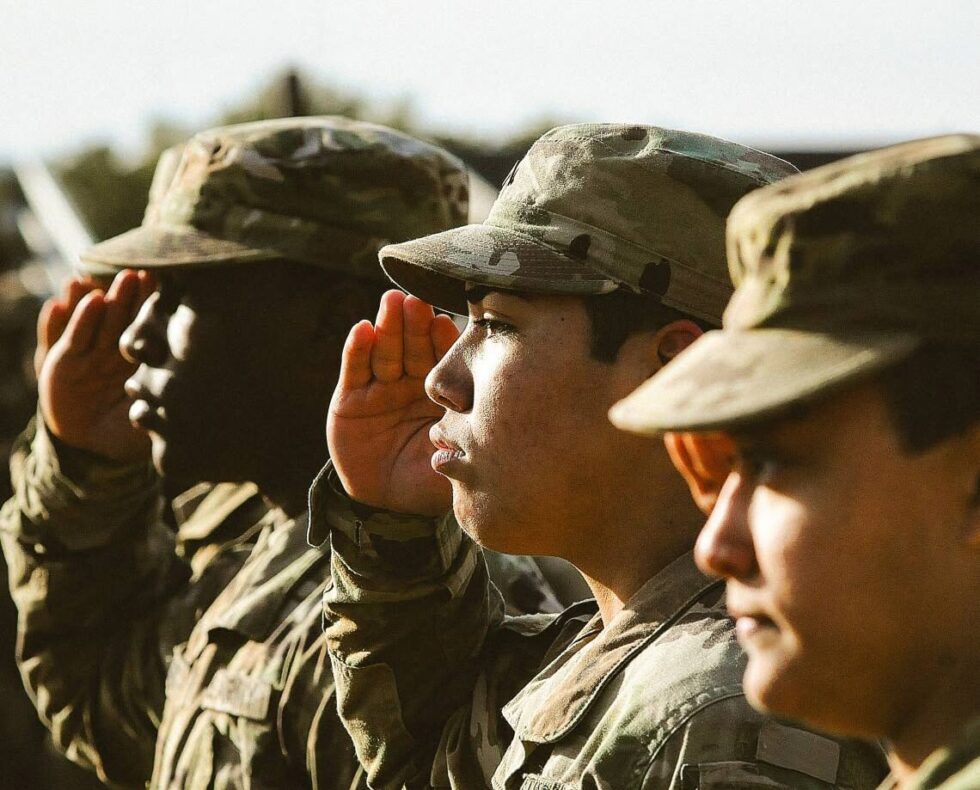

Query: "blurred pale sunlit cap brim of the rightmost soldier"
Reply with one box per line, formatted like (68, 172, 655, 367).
(609, 329, 921, 435)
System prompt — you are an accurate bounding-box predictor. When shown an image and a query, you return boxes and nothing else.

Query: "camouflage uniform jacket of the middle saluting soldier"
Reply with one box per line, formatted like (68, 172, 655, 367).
(311, 467, 885, 790)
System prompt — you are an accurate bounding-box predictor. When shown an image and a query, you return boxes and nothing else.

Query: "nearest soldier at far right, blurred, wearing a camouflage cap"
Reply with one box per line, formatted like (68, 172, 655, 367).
(611, 135, 980, 790)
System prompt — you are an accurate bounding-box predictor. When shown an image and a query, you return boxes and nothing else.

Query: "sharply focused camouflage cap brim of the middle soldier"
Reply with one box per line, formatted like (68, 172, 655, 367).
(378, 225, 617, 315)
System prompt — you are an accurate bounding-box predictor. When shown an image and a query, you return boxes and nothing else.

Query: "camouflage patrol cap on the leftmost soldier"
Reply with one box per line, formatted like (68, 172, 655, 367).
(82, 117, 468, 278)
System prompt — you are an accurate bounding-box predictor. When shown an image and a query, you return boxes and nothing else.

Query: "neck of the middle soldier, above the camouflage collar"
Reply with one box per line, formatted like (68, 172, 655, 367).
(566, 470, 704, 625)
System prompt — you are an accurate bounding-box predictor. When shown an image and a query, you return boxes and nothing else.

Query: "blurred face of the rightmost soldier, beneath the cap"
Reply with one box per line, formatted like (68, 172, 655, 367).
(696, 384, 980, 737)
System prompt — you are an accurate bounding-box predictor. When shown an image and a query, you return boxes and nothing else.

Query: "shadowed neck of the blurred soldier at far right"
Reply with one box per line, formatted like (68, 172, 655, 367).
(888, 646, 980, 787)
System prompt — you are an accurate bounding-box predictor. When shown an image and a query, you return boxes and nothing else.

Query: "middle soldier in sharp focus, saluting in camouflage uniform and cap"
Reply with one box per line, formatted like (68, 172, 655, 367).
(311, 124, 884, 790)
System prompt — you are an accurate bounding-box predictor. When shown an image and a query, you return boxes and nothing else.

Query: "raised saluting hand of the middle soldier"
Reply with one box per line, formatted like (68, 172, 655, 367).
(327, 291, 459, 516)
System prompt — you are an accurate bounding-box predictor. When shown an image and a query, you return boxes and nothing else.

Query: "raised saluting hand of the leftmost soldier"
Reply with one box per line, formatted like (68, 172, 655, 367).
(34, 271, 154, 461)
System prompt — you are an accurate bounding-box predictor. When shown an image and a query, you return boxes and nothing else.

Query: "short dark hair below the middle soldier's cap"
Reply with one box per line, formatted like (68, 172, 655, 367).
(584, 288, 717, 362)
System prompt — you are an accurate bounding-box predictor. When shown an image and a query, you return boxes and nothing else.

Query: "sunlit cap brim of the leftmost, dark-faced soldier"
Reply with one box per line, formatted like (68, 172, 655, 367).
(81, 225, 282, 274)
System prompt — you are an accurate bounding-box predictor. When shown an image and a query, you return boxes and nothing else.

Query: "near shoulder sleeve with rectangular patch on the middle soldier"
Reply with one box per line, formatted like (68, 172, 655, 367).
(642, 694, 887, 790)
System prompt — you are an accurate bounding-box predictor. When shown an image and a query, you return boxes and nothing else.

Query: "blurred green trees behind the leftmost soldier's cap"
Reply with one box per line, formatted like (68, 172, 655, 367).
(51, 70, 557, 239)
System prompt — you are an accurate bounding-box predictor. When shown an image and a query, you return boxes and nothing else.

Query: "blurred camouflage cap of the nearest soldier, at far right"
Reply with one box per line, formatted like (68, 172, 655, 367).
(610, 135, 980, 434)
